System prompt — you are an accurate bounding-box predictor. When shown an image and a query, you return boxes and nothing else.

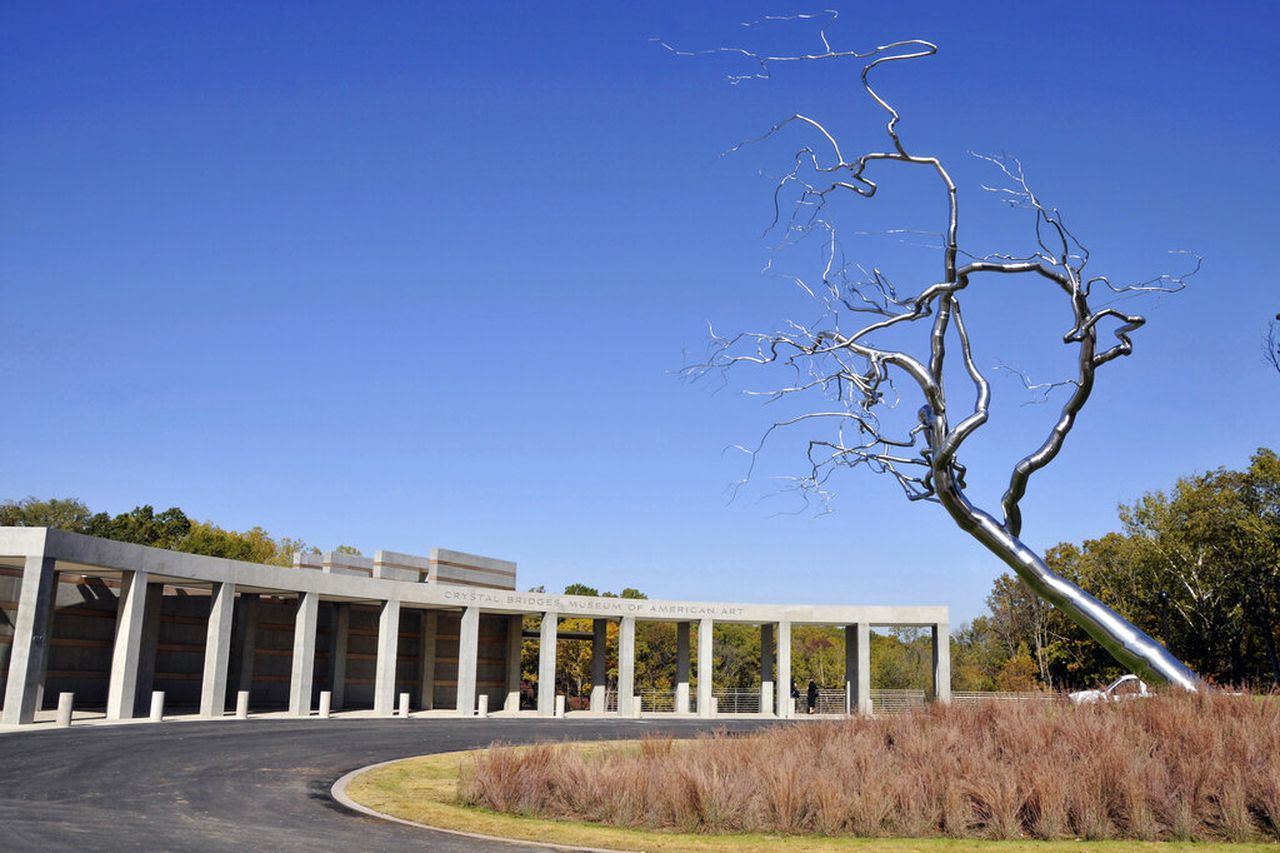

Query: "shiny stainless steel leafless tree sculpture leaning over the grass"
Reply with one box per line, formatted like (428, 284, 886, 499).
(662, 13, 1201, 690)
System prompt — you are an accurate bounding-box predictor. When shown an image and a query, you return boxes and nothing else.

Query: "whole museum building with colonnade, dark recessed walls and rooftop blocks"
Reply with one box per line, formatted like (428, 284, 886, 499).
(0, 528, 951, 724)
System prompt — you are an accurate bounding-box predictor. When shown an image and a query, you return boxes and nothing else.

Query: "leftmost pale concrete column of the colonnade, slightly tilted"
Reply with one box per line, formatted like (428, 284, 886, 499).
(0, 556, 58, 725)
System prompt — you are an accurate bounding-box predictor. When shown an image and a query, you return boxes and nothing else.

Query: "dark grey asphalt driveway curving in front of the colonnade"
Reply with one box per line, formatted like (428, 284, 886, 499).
(0, 719, 759, 852)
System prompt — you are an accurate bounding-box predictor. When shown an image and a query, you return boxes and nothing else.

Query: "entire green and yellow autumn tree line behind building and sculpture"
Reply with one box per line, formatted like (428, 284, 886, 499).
(0, 448, 1280, 697)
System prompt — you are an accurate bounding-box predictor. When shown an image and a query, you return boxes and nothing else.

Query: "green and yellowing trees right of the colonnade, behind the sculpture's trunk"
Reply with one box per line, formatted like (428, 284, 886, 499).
(954, 448, 1280, 689)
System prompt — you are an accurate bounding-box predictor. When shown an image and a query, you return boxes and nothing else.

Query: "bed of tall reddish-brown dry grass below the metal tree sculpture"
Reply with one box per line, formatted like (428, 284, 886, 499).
(460, 695, 1280, 841)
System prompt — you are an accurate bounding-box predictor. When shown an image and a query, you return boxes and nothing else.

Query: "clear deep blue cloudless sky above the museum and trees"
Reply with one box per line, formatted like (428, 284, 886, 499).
(0, 3, 1280, 622)
